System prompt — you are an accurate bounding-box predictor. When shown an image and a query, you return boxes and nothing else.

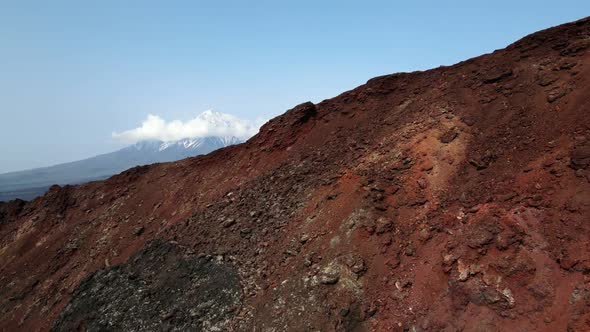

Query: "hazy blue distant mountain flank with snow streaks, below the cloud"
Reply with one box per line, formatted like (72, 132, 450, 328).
(0, 136, 242, 201)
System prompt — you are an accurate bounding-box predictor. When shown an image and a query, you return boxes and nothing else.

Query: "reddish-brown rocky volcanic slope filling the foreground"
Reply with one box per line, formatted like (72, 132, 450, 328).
(0, 18, 590, 331)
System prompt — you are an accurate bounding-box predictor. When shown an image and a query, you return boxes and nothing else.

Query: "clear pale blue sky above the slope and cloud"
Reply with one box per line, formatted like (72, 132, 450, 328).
(0, 0, 590, 173)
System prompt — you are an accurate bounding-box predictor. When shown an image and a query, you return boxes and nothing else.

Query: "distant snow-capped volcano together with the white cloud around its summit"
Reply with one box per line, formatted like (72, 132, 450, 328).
(0, 110, 260, 201)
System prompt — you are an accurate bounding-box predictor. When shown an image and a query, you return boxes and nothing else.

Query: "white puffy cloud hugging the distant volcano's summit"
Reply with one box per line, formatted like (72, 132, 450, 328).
(112, 110, 263, 144)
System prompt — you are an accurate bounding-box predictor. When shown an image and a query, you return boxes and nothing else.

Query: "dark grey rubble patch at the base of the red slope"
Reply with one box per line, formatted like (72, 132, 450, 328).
(52, 241, 241, 331)
